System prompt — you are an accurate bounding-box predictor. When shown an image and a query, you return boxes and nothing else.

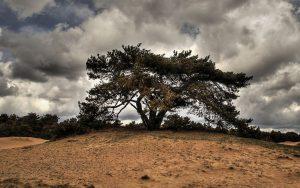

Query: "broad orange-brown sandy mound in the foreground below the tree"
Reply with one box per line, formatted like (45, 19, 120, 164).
(0, 131, 300, 188)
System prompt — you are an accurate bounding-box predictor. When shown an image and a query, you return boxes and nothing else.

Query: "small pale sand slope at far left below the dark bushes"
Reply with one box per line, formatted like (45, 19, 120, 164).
(0, 137, 47, 150)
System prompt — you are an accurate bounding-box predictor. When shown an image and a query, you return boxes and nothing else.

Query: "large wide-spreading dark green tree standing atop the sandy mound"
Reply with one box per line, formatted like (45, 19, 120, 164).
(79, 44, 252, 130)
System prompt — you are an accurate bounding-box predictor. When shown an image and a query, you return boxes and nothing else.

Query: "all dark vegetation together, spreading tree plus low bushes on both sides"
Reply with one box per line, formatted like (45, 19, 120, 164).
(0, 44, 300, 142)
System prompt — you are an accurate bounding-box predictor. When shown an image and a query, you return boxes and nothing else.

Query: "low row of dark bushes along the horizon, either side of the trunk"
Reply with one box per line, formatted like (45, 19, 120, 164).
(0, 113, 300, 142)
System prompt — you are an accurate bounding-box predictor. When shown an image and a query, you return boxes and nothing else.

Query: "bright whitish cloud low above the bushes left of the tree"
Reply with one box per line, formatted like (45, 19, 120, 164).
(0, 77, 91, 117)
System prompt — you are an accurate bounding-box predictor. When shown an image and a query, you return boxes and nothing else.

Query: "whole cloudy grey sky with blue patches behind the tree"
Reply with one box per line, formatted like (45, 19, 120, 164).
(0, 0, 300, 132)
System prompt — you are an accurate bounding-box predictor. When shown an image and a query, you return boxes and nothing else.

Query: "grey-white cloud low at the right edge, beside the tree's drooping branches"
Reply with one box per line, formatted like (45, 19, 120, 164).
(238, 63, 300, 131)
